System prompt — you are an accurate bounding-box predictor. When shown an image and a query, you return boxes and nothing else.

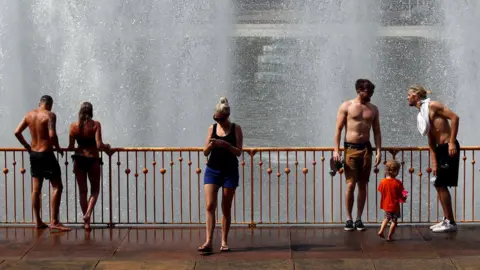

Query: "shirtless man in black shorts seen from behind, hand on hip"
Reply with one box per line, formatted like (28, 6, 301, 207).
(15, 95, 70, 231)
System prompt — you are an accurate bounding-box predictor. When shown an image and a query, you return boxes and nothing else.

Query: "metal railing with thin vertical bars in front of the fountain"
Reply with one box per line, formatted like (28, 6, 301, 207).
(0, 147, 480, 226)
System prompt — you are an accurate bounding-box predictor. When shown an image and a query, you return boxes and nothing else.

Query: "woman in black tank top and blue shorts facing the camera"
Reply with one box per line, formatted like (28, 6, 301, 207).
(198, 97, 243, 253)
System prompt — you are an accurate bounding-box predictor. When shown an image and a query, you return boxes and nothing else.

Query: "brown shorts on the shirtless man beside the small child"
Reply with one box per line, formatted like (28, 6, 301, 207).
(344, 142, 372, 183)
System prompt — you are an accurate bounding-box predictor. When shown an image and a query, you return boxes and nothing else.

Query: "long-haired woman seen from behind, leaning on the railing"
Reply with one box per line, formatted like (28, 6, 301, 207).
(68, 102, 110, 230)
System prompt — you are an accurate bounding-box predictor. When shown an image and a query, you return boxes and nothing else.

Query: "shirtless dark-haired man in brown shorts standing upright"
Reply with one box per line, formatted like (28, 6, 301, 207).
(333, 79, 382, 231)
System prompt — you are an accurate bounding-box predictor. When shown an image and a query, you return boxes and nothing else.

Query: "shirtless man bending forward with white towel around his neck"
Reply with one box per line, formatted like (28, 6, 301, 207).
(408, 86, 460, 232)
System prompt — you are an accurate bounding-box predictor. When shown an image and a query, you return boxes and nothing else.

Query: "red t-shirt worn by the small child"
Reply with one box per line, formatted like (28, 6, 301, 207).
(378, 178, 403, 213)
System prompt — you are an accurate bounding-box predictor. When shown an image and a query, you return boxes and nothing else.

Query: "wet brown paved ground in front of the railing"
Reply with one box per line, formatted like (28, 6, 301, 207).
(0, 225, 480, 270)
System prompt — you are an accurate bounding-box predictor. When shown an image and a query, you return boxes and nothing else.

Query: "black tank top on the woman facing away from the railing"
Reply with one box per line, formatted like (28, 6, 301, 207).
(207, 123, 238, 171)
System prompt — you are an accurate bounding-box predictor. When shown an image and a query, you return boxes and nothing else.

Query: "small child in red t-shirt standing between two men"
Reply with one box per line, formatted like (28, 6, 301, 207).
(378, 160, 406, 241)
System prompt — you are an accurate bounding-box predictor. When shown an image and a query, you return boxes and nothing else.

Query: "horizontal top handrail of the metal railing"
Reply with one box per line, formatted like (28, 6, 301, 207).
(0, 146, 480, 152)
